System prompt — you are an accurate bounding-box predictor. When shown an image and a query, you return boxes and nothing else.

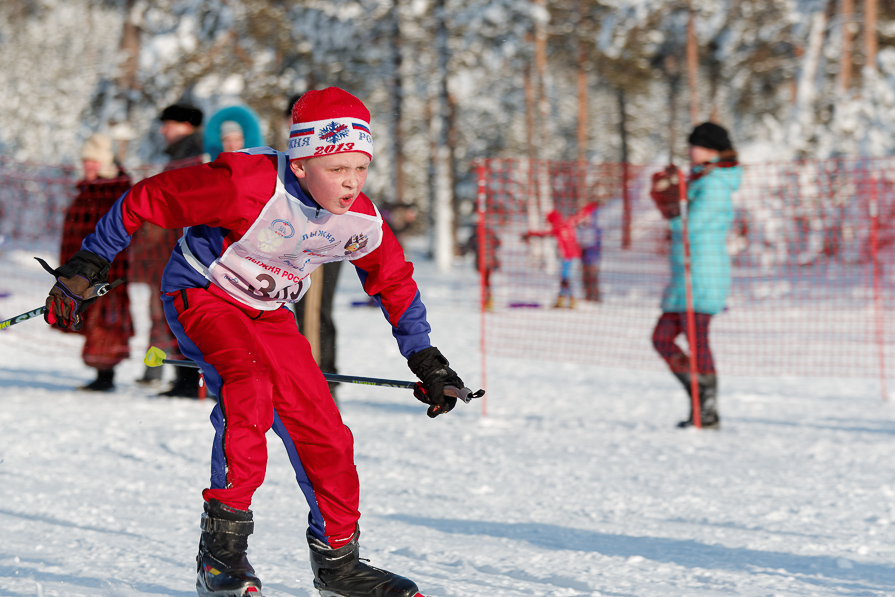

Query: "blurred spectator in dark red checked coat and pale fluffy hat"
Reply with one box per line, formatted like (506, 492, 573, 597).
(54, 133, 134, 392)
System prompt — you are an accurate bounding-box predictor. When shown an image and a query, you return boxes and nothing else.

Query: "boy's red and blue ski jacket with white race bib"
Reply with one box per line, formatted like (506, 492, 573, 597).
(81, 148, 431, 357)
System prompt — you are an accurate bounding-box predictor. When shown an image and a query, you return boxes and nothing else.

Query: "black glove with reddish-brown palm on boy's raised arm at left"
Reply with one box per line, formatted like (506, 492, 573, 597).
(38, 251, 109, 332)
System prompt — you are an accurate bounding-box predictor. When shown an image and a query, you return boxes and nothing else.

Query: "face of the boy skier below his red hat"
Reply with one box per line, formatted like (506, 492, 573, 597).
(290, 151, 370, 215)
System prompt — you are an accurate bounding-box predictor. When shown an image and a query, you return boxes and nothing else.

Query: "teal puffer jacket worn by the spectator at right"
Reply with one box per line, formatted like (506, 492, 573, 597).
(662, 164, 743, 315)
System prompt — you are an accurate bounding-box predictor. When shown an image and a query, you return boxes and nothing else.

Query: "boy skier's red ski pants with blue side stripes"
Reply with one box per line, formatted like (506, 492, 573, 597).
(162, 285, 360, 547)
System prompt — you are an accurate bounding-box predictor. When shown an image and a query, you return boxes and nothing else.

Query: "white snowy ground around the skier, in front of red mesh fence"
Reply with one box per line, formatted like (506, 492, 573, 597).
(0, 243, 895, 597)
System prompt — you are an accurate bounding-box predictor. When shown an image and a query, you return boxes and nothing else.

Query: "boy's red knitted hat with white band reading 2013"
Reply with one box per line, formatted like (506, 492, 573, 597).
(289, 87, 373, 160)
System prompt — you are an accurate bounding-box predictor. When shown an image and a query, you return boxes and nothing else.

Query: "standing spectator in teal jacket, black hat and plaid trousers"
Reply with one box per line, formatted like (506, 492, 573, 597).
(652, 122, 742, 429)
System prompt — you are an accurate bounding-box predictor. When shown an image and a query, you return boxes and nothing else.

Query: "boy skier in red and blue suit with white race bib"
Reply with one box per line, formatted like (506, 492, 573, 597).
(46, 87, 469, 597)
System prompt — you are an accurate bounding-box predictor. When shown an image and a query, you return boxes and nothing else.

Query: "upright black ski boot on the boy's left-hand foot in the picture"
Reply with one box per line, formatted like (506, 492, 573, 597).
(196, 500, 261, 597)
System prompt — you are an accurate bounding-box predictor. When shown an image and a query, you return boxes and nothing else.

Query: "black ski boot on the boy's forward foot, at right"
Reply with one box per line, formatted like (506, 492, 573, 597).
(308, 528, 423, 597)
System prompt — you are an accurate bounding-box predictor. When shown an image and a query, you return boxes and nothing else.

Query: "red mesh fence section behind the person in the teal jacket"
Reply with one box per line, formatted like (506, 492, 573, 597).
(477, 158, 895, 380)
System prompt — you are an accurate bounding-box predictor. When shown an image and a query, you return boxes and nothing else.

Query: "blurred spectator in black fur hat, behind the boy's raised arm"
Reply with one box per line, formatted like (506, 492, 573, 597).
(129, 103, 204, 398)
